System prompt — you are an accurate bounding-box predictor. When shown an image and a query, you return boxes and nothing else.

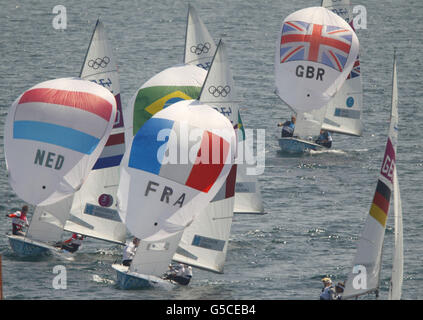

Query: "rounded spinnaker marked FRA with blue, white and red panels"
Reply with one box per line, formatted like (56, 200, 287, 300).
(118, 101, 236, 241)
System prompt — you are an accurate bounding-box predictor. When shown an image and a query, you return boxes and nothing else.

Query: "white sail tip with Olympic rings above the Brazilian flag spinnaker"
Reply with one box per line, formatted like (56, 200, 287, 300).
(184, 4, 216, 70)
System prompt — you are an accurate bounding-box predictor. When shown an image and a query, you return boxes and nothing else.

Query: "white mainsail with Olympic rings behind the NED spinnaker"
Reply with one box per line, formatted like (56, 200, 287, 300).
(65, 20, 126, 244)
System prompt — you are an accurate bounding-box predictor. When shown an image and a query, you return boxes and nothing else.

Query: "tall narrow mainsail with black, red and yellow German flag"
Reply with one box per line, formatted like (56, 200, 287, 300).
(343, 53, 398, 299)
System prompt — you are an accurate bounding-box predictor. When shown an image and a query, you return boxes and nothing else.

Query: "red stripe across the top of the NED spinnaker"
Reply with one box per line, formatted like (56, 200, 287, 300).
(19, 88, 113, 122)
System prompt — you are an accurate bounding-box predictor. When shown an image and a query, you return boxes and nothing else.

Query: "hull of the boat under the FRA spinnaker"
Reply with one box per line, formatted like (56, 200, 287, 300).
(112, 264, 175, 290)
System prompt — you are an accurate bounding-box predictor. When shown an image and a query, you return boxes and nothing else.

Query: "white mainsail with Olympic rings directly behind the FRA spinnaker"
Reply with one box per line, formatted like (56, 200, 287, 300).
(173, 41, 239, 272)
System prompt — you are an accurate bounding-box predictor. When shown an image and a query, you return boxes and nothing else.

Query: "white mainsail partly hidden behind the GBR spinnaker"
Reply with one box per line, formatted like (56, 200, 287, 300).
(322, 0, 363, 137)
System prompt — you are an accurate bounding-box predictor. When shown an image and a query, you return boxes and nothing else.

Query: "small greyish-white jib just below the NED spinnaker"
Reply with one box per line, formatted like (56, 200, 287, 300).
(26, 195, 73, 243)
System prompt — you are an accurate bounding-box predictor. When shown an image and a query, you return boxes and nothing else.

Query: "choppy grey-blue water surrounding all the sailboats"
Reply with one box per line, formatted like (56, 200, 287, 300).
(0, 0, 423, 299)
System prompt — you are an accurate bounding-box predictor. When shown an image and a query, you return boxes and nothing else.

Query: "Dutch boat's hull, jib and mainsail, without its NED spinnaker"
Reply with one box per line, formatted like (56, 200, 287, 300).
(5, 20, 126, 258)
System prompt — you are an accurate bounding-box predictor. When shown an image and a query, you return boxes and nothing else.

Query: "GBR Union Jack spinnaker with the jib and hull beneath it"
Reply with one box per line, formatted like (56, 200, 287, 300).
(275, 7, 359, 153)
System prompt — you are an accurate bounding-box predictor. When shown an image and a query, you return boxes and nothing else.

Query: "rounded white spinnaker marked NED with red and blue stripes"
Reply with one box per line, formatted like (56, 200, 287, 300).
(4, 78, 116, 205)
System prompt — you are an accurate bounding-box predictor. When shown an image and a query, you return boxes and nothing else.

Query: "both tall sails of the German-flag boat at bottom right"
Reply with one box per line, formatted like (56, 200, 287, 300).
(342, 56, 403, 299)
